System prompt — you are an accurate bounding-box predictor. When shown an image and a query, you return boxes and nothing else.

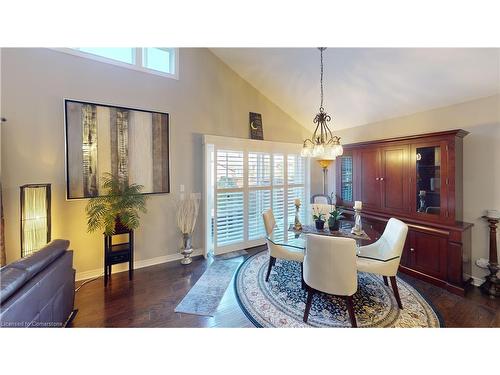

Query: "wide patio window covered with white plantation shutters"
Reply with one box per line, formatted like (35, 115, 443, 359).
(205, 136, 309, 254)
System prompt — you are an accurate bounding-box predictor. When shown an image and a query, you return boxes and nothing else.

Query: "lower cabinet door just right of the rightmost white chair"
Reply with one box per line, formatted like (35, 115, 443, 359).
(410, 230, 448, 279)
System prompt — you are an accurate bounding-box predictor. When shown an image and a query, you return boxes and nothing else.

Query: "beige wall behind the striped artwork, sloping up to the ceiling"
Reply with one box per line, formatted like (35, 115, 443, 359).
(1, 49, 305, 272)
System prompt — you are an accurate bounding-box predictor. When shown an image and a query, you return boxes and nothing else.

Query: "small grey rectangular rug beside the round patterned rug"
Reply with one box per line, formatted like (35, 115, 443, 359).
(174, 260, 240, 316)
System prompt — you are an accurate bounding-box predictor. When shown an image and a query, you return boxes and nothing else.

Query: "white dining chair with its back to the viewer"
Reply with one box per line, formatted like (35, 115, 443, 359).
(303, 234, 358, 327)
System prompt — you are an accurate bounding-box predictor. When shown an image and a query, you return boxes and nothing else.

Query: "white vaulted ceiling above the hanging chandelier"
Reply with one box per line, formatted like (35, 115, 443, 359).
(211, 48, 500, 129)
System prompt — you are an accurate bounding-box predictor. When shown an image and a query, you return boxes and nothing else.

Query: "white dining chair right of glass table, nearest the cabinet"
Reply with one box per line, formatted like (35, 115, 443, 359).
(356, 218, 408, 309)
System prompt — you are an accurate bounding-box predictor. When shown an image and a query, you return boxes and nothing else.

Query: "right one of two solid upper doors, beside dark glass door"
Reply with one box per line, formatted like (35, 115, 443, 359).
(380, 145, 410, 213)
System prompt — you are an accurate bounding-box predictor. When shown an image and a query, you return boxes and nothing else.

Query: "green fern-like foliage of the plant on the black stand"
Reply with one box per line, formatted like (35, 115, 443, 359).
(85, 173, 146, 236)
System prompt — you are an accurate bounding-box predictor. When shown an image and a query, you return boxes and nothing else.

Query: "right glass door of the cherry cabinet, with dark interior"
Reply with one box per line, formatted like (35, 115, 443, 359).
(414, 146, 442, 216)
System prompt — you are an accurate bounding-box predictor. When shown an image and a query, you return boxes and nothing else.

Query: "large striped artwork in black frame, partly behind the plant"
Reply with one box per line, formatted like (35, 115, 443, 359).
(64, 100, 170, 199)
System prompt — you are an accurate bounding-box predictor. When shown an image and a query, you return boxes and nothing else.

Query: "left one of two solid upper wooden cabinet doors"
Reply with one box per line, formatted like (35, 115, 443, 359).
(359, 148, 382, 209)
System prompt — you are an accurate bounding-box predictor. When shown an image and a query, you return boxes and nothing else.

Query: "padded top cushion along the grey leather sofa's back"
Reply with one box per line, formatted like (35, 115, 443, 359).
(6, 240, 69, 280)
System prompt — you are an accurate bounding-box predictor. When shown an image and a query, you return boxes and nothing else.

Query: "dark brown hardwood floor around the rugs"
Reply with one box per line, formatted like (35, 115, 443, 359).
(71, 249, 500, 327)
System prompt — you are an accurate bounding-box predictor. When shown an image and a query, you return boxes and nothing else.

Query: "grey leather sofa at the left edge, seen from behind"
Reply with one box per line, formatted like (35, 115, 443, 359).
(0, 240, 75, 327)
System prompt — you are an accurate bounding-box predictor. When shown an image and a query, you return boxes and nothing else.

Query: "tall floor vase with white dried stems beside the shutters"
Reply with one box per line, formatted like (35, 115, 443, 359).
(177, 194, 200, 265)
